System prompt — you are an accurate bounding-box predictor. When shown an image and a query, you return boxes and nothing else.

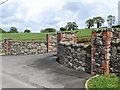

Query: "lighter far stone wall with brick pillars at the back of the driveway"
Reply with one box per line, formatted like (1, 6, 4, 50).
(1, 32, 75, 55)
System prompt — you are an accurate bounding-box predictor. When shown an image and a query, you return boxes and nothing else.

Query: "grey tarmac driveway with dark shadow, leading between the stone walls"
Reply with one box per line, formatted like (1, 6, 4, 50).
(2, 53, 91, 88)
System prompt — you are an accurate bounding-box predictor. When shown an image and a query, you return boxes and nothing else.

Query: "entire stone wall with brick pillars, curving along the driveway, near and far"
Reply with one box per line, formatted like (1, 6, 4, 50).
(0, 29, 120, 75)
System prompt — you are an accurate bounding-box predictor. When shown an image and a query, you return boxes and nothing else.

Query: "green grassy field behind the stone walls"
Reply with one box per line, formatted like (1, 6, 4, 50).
(0, 29, 93, 40)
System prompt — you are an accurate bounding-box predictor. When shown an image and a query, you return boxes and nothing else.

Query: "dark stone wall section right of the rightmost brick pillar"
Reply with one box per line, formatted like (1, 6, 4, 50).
(110, 29, 120, 76)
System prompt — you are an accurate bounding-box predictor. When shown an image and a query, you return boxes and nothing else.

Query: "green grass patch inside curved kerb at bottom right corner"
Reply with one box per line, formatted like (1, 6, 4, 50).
(88, 74, 120, 90)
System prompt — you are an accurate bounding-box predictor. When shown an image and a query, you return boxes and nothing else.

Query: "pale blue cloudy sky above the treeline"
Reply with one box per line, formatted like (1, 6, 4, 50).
(0, 0, 119, 33)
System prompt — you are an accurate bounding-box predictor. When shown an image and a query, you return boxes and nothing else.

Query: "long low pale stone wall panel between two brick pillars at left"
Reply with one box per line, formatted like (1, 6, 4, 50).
(8, 41, 47, 55)
